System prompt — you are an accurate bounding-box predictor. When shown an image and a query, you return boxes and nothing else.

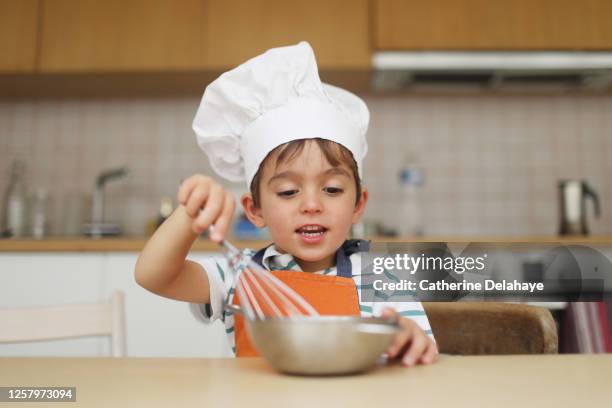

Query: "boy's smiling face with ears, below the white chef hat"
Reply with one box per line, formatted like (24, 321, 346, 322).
(243, 142, 367, 272)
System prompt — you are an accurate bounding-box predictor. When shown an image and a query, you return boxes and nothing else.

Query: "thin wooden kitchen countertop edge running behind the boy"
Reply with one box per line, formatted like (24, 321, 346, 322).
(0, 235, 612, 252)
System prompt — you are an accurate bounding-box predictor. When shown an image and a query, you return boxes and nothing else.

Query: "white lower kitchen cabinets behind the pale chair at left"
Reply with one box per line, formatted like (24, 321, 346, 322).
(0, 252, 232, 357)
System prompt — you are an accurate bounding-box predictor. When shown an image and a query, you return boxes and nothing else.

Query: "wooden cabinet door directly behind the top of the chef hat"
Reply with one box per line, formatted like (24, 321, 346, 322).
(203, 0, 370, 69)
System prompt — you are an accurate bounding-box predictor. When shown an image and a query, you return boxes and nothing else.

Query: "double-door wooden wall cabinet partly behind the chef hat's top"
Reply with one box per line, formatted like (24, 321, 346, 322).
(40, 0, 370, 73)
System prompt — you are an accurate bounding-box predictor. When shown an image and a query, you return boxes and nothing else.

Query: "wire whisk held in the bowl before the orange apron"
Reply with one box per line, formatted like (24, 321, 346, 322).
(209, 226, 319, 320)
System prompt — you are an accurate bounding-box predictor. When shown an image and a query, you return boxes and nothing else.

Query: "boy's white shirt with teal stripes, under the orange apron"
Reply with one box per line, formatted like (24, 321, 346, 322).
(189, 245, 435, 354)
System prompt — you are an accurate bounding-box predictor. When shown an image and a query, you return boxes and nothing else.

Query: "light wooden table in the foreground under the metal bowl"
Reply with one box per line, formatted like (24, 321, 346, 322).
(0, 354, 612, 408)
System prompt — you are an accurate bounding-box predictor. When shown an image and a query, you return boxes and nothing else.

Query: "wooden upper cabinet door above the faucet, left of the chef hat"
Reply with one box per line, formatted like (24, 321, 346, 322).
(40, 0, 205, 72)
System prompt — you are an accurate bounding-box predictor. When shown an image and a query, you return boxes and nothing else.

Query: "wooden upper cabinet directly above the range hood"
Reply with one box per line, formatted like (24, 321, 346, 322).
(372, 0, 612, 50)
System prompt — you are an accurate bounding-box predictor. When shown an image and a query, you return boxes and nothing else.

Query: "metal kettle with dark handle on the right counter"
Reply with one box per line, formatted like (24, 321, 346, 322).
(559, 180, 600, 235)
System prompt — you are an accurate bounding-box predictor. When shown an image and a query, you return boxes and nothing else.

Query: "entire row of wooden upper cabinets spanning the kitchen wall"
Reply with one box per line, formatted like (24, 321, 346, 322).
(0, 0, 612, 78)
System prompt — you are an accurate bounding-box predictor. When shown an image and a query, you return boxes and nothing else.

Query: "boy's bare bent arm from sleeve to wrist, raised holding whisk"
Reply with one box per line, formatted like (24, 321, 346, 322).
(135, 205, 210, 303)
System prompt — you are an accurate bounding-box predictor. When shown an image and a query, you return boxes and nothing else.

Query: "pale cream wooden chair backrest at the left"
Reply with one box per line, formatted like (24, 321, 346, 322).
(0, 291, 126, 357)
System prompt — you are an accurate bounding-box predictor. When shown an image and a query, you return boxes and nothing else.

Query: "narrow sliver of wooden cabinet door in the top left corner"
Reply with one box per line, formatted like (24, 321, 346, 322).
(0, 0, 38, 72)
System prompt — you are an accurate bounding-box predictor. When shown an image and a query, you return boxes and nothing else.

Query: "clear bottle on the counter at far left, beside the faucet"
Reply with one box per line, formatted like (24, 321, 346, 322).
(3, 160, 27, 237)
